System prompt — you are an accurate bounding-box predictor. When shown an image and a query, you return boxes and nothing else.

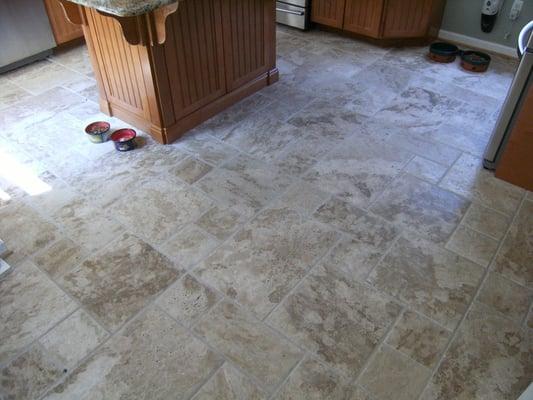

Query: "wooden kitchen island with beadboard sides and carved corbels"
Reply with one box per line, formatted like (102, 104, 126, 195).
(56, 0, 278, 143)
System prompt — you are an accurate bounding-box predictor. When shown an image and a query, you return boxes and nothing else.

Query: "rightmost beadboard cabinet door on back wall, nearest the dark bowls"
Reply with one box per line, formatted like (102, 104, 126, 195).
(383, 0, 433, 38)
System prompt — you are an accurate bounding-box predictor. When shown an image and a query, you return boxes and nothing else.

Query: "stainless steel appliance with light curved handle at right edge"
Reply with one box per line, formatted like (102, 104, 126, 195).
(483, 21, 533, 169)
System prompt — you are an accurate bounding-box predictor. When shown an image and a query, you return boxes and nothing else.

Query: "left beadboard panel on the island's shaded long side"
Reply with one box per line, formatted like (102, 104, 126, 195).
(158, 0, 226, 120)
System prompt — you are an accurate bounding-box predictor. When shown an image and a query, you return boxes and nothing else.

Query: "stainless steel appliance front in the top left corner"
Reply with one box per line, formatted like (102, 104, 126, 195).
(0, 0, 56, 73)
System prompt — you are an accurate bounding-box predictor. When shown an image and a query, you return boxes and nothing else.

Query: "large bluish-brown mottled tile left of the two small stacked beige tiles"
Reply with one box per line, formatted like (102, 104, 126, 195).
(370, 175, 469, 243)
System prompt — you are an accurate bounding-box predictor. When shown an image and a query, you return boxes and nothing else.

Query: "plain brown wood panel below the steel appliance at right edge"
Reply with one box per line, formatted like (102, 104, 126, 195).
(496, 83, 533, 190)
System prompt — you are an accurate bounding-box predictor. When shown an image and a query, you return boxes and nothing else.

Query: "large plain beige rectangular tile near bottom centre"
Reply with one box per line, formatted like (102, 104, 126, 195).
(194, 302, 302, 392)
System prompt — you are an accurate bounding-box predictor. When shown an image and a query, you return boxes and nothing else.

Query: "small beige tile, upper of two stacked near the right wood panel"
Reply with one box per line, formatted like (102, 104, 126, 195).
(462, 203, 511, 240)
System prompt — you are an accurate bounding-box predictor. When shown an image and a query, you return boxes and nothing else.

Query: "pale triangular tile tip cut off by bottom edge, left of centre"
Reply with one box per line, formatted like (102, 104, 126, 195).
(193, 363, 267, 400)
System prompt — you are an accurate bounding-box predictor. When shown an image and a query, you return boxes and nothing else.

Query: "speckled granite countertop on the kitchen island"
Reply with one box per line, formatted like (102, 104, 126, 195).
(70, 0, 182, 17)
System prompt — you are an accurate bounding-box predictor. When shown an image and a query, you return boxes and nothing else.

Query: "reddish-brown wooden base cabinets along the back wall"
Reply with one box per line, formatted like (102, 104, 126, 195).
(311, 0, 445, 39)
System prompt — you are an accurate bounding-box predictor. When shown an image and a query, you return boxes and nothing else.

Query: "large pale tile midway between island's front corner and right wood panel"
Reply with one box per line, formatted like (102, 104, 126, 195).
(304, 136, 411, 207)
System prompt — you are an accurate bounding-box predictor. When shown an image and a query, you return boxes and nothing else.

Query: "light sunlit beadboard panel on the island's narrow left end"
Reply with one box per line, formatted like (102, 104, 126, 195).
(86, 8, 150, 117)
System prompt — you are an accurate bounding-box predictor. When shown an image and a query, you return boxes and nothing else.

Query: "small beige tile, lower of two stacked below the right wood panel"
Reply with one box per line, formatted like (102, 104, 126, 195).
(446, 226, 498, 267)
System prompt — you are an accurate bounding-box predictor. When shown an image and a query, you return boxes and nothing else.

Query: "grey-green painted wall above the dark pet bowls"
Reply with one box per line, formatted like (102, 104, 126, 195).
(441, 0, 533, 47)
